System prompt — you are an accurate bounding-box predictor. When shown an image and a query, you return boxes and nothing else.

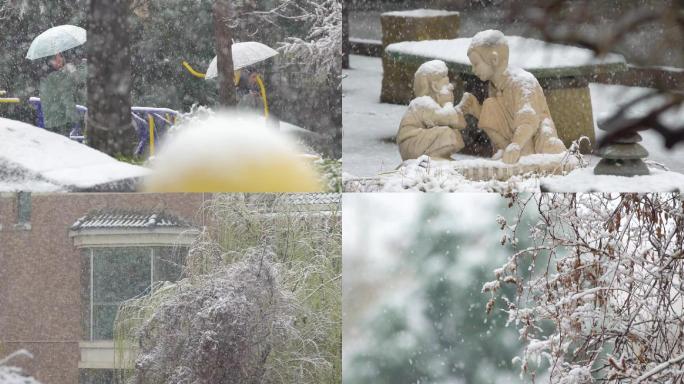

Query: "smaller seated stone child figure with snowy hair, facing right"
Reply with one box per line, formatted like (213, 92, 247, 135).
(397, 60, 479, 160)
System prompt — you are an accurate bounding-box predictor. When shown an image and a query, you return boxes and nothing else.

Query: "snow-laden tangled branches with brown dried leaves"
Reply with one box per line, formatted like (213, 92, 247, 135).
(483, 194, 684, 384)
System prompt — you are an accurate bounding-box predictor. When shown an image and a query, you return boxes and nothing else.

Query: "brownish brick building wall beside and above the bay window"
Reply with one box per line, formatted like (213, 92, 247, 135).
(0, 193, 209, 384)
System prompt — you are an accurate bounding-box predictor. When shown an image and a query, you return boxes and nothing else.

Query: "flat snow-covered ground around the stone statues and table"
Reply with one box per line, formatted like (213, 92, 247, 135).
(342, 55, 684, 191)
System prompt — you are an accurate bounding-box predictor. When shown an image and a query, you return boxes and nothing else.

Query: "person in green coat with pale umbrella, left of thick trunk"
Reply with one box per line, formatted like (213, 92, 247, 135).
(26, 25, 86, 137)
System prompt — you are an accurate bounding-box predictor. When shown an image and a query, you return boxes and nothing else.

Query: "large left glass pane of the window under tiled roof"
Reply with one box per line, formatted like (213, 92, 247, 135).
(93, 247, 151, 340)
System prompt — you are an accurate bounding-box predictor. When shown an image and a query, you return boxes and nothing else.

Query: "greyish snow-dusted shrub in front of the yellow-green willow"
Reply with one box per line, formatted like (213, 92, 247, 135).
(118, 249, 294, 384)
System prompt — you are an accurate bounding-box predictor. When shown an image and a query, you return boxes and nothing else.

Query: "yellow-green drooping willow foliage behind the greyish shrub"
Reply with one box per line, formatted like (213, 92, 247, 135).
(206, 194, 342, 383)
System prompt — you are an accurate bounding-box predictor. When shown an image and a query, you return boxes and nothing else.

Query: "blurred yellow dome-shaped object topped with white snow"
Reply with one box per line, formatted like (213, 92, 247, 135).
(145, 113, 322, 192)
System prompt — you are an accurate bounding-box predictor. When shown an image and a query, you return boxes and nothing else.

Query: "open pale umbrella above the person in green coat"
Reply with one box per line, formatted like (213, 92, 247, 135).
(26, 25, 86, 60)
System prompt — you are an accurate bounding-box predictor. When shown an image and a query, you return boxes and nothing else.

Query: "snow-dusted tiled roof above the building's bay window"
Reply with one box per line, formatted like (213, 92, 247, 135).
(71, 211, 192, 231)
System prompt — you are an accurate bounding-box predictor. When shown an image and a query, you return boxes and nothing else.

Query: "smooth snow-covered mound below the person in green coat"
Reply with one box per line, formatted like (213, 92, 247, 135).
(0, 118, 149, 192)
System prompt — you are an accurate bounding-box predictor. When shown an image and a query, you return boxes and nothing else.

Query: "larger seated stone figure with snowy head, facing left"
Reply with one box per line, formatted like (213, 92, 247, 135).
(468, 30, 566, 164)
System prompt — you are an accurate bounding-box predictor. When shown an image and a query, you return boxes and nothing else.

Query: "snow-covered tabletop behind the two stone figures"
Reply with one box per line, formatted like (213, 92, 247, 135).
(385, 32, 627, 77)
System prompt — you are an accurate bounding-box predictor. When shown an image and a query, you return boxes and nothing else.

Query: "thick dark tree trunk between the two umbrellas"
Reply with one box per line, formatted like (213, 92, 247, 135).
(87, 0, 136, 156)
